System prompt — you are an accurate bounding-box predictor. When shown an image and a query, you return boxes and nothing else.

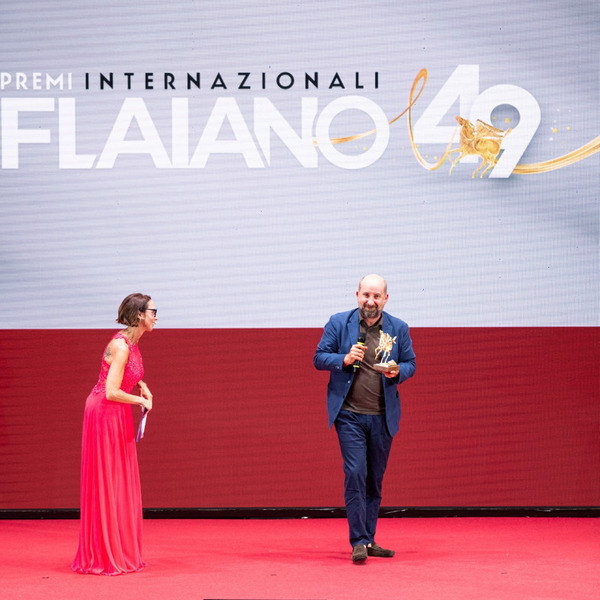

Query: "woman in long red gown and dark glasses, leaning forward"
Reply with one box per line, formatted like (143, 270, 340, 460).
(71, 294, 157, 575)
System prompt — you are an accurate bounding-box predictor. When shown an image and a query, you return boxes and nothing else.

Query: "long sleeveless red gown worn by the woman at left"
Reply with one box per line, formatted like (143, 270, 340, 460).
(71, 332, 146, 575)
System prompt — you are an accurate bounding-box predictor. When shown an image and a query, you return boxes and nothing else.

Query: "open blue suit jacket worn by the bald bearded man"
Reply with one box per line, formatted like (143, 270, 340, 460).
(313, 308, 416, 436)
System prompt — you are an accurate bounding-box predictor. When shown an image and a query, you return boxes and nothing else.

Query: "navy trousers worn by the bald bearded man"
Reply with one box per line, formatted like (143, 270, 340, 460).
(335, 410, 393, 547)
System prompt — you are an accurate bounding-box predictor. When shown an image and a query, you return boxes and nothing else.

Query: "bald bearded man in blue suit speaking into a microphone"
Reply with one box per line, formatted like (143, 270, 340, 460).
(314, 275, 416, 563)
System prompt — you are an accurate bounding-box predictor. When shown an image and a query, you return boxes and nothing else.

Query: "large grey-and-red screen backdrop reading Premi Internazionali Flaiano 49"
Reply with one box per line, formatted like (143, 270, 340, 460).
(0, 0, 600, 508)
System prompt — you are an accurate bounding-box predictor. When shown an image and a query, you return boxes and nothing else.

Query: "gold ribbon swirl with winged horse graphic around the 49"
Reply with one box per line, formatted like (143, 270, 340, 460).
(324, 69, 600, 177)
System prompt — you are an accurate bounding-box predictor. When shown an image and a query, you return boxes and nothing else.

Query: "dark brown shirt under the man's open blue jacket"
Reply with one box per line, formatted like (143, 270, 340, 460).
(342, 318, 385, 415)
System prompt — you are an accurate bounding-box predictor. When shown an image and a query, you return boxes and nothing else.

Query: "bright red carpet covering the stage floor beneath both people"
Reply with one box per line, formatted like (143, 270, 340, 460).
(0, 517, 600, 600)
